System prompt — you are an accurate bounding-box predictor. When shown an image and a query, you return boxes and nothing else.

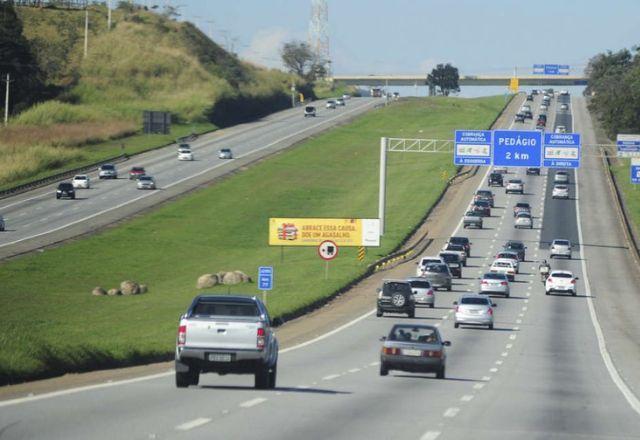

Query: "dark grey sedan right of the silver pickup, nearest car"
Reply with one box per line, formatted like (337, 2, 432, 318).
(380, 324, 451, 379)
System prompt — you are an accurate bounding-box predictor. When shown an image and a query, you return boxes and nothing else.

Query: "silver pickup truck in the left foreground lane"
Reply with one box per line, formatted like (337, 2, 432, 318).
(175, 295, 278, 389)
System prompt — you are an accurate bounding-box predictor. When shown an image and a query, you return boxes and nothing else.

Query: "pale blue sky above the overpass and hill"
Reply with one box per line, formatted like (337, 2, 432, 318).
(169, 0, 640, 74)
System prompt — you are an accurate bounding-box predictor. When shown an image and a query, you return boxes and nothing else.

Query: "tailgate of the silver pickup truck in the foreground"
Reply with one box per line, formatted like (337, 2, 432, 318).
(183, 318, 261, 350)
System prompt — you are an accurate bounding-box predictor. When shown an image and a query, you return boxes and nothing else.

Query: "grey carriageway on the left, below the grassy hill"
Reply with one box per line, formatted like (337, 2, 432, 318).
(0, 98, 383, 259)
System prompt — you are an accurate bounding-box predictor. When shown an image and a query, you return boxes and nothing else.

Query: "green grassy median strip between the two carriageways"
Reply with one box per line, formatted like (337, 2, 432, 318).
(0, 97, 505, 383)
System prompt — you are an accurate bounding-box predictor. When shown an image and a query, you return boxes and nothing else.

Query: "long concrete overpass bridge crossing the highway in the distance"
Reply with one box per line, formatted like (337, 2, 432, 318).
(332, 73, 587, 87)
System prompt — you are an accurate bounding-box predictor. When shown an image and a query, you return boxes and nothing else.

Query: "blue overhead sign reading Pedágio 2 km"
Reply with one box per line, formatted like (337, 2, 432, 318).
(493, 130, 542, 167)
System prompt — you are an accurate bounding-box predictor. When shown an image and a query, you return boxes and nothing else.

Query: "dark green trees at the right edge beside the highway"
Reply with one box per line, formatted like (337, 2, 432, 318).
(585, 47, 640, 138)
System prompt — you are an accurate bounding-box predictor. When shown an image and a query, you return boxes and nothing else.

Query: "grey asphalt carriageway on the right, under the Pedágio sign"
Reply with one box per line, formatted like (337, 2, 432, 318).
(0, 92, 640, 440)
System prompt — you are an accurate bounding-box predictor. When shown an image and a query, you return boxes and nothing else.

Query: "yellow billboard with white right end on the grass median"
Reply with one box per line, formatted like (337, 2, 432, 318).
(269, 217, 380, 246)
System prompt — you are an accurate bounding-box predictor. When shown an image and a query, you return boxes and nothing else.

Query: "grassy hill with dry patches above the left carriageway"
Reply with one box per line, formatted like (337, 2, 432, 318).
(0, 5, 302, 187)
